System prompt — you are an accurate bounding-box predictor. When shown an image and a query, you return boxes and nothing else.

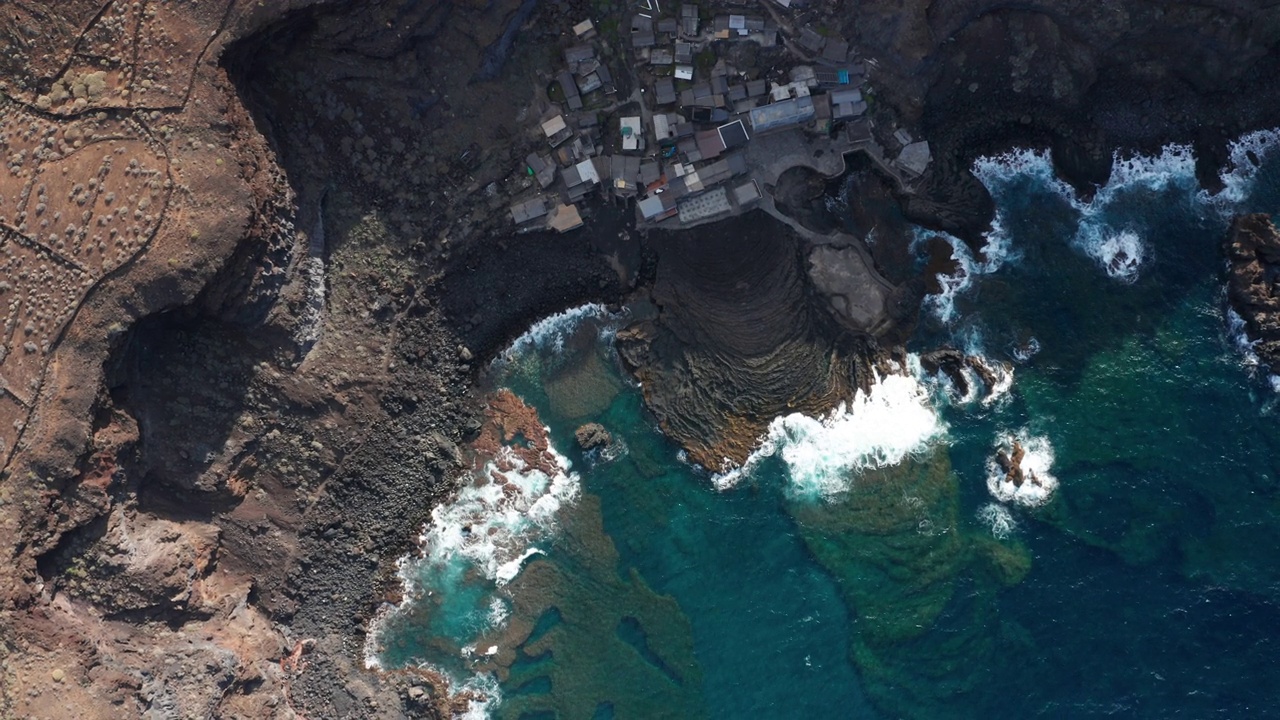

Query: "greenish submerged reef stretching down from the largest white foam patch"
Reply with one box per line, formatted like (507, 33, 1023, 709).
(788, 447, 1032, 717)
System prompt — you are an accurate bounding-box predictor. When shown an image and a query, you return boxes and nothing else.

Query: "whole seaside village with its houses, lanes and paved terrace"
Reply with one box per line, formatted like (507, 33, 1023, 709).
(511, 0, 931, 232)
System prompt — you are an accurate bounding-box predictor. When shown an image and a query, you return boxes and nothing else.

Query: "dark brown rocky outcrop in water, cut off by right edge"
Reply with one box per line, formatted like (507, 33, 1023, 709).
(1226, 213, 1280, 372)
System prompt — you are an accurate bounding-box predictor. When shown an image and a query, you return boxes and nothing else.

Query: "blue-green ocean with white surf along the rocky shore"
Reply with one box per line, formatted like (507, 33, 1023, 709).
(369, 133, 1280, 720)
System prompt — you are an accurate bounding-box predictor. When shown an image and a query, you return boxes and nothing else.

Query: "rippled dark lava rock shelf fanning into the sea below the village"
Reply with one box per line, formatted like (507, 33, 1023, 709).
(618, 212, 890, 469)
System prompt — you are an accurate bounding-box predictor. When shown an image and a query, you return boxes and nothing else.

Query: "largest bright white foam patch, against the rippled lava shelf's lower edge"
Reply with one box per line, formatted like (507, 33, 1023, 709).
(713, 363, 946, 498)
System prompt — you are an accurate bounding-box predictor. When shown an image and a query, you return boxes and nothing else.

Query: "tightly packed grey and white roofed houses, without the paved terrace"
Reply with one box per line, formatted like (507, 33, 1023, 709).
(511, 3, 929, 232)
